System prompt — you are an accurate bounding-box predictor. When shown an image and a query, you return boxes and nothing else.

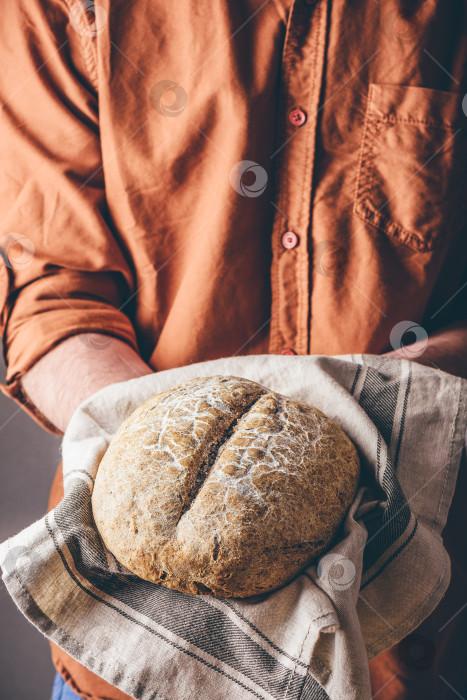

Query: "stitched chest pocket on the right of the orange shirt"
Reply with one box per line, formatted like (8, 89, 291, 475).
(353, 83, 467, 252)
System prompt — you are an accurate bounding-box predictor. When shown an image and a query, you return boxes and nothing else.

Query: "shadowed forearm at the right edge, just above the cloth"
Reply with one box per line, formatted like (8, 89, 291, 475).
(383, 321, 467, 379)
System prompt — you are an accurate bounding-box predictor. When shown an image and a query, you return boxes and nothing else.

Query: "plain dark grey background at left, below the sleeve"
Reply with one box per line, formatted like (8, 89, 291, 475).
(0, 344, 61, 700)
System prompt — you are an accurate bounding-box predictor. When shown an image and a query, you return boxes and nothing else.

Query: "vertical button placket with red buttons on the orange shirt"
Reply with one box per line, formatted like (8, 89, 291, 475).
(269, 0, 329, 354)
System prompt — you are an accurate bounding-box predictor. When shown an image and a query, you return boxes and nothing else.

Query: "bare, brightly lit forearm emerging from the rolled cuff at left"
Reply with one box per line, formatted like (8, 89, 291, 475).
(21, 333, 154, 432)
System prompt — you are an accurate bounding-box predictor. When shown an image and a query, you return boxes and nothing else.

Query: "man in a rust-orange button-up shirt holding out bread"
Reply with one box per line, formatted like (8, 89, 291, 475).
(0, 0, 467, 700)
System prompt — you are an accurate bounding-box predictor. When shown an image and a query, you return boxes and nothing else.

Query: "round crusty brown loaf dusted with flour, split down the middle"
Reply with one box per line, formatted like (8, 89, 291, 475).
(92, 376, 360, 597)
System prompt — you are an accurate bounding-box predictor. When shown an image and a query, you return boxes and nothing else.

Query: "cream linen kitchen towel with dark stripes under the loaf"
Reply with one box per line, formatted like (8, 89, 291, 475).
(0, 354, 467, 700)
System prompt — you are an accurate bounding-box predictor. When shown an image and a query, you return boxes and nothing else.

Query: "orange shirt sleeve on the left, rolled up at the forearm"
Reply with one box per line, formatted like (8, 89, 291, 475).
(0, 0, 137, 432)
